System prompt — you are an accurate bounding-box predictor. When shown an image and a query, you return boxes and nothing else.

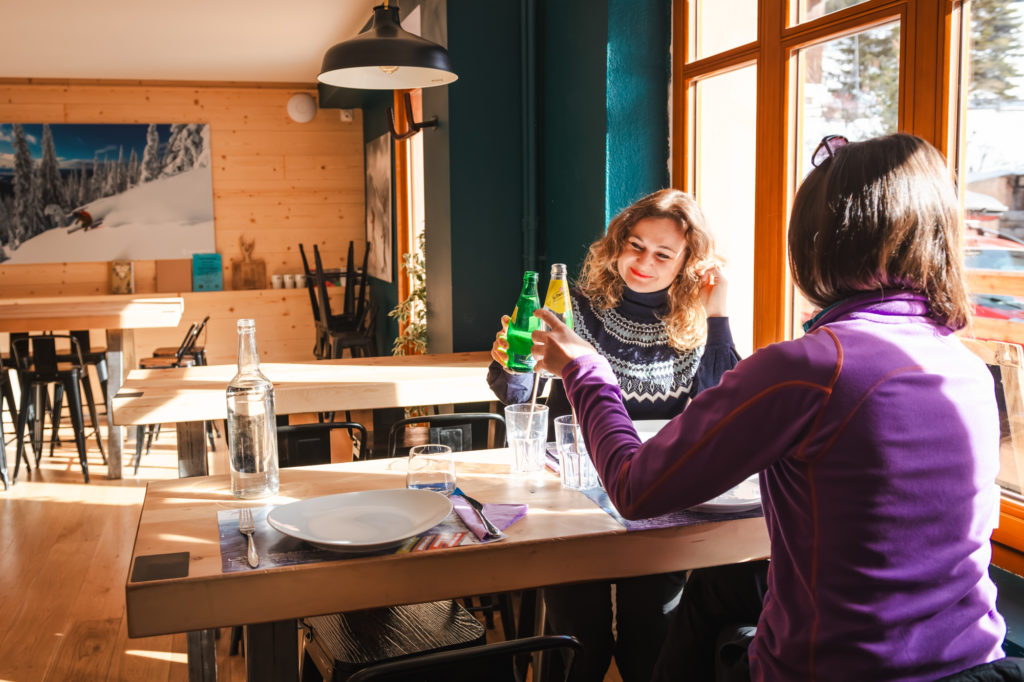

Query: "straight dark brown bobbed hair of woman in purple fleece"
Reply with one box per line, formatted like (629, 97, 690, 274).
(790, 133, 971, 330)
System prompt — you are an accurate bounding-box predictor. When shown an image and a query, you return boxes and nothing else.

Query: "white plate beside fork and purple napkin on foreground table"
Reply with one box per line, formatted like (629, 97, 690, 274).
(266, 487, 452, 552)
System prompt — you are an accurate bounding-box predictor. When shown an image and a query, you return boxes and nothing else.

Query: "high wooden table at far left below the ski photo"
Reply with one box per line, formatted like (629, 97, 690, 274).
(0, 295, 185, 478)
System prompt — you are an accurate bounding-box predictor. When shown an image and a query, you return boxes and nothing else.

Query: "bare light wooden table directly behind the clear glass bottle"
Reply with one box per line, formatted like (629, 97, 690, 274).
(112, 351, 495, 477)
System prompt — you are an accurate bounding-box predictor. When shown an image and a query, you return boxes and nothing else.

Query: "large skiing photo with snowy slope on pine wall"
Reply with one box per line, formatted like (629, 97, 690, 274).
(0, 123, 215, 264)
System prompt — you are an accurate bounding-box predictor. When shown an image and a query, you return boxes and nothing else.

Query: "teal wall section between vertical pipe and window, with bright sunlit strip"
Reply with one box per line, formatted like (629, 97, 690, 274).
(538, 0, 672, 275)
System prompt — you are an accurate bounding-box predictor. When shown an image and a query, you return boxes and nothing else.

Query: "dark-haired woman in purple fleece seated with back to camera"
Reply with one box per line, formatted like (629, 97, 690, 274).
(534, 134, 1006, 682)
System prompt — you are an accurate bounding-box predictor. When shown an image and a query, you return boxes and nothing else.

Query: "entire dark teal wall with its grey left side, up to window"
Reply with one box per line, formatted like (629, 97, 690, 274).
(344, 0, 671, 352)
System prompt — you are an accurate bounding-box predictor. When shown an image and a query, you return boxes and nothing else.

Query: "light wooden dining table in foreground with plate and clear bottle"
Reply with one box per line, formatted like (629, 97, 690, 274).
(125, 449, 768, 680)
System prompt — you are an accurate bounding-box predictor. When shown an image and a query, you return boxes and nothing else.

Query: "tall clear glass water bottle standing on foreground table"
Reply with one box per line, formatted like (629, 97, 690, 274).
(227, 319, 279, 499)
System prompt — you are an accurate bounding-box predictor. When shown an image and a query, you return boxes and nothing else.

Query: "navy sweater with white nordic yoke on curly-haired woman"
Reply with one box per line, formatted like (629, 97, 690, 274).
(487, 282, 739, 424)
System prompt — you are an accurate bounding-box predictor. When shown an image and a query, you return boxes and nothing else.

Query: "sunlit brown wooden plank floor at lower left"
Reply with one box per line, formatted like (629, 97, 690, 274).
(0, 405, 620, 682)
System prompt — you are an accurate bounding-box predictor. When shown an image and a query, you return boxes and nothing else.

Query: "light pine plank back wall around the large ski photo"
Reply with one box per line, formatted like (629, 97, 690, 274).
(0, 80, 366, 363)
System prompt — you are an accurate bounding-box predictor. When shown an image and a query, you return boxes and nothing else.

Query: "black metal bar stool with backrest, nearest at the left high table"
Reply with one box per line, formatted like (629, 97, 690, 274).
(11, 334, 102, 483)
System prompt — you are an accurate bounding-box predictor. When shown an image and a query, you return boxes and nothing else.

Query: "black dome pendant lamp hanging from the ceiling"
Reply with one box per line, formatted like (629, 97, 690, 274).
(316, 0, 459, 90)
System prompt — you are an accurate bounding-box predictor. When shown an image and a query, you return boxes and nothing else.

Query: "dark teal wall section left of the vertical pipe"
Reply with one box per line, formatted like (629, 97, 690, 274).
(442, 0, 522, 351)
